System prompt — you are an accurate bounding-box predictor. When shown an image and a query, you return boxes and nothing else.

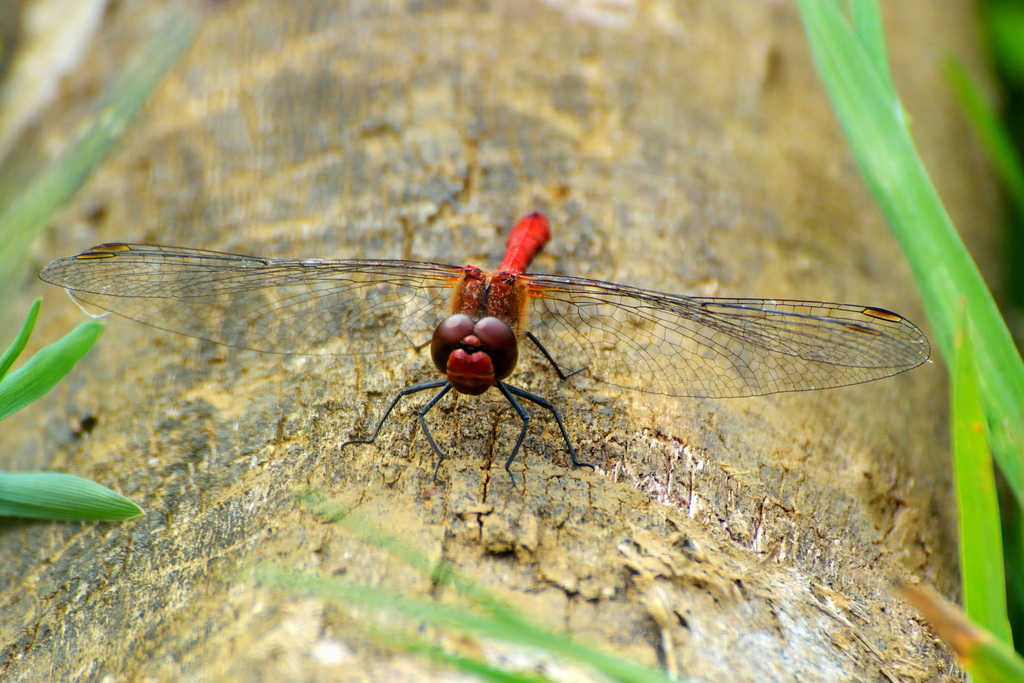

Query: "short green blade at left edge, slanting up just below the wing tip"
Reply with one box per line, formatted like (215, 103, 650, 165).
(0, 323, 103, 420)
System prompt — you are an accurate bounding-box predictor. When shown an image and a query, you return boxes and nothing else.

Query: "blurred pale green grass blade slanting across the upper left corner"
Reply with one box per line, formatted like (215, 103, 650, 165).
(0, 14, 197, 299)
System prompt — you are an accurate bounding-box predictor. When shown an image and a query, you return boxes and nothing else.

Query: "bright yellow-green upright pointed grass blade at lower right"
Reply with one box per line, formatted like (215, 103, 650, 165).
(951, 309, 1013, 646)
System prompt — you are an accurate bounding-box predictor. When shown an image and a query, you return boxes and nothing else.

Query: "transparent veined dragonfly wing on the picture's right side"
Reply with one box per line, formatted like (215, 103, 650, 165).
(524, 274, 931, 398)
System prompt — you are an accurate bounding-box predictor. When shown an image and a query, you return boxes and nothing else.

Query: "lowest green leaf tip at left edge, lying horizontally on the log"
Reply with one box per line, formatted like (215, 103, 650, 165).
(0, 472, 142, 521)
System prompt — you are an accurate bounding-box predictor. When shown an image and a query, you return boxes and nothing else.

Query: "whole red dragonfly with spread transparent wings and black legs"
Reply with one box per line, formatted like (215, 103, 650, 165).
(39, 213, 931, 477)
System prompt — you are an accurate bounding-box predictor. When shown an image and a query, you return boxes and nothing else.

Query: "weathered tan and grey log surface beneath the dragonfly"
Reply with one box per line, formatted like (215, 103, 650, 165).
(0, 0, 996, 681)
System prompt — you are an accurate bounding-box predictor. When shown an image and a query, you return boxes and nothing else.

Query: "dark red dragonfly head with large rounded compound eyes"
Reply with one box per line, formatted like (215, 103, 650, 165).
(430, 313, 519, 396)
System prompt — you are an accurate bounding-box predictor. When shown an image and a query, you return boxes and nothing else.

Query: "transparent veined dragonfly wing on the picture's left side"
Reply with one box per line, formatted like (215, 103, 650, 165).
(39, 244, 462, 355)
